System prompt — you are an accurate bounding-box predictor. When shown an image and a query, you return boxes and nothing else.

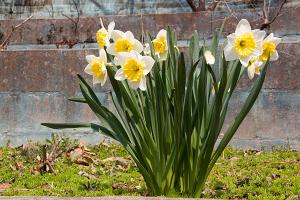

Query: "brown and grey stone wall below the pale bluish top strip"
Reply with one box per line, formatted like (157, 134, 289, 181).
(0, 7, 300, 148)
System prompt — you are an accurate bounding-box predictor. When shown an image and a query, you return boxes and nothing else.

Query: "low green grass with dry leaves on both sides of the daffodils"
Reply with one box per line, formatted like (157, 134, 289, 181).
(0, 138, 300, 200)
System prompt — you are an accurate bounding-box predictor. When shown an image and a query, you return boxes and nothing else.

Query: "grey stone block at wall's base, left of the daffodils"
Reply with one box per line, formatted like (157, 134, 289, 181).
(0, 92, 107, 146)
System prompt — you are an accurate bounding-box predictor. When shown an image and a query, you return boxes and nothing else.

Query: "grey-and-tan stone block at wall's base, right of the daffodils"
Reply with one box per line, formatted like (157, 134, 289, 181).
(222, 89, 300, 141)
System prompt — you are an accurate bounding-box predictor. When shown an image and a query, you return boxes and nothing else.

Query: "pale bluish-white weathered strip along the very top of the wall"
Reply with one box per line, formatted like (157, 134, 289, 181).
(0, 0, 300, 19)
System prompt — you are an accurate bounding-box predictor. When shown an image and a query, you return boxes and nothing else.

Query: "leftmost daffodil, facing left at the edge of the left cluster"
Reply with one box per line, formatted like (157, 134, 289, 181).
(84, 49, 107, 86)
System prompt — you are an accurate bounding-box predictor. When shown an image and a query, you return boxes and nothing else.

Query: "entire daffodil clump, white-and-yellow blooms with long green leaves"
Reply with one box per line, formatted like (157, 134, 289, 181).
(43, 19, 280, 197)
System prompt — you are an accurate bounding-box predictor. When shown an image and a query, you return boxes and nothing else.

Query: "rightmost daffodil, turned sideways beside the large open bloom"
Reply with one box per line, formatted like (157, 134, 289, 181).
(259, 33, 281, 62)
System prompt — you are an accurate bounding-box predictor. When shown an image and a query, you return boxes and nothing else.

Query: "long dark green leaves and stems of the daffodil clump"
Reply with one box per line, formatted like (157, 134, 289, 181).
(43, 29, 268, 197)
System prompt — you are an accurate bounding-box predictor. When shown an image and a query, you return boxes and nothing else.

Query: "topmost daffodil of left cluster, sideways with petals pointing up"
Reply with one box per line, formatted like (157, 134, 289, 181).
(96, 18, 115, 48)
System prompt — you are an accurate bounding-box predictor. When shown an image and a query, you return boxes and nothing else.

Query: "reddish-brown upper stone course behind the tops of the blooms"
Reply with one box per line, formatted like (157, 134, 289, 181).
(0, 8, 300, 44)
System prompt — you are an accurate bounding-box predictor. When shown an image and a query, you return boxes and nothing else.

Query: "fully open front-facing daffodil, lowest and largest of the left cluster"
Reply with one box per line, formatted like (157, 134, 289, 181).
(115, 51, 154, 91)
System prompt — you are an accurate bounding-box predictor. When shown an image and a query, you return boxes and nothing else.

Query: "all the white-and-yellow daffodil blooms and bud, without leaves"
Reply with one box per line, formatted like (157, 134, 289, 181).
(85, 18, 281, 90)
